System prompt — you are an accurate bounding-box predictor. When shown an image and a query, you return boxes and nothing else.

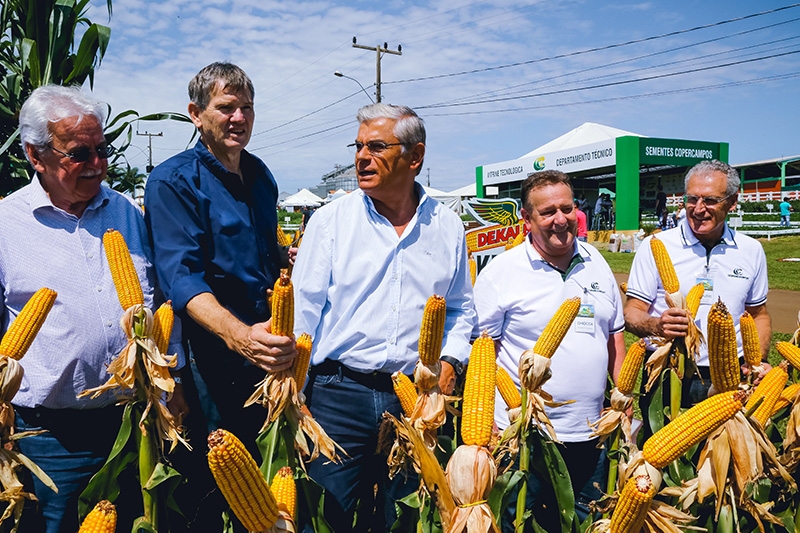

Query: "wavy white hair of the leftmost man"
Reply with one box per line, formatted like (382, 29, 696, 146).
(19, 85, 108, 160)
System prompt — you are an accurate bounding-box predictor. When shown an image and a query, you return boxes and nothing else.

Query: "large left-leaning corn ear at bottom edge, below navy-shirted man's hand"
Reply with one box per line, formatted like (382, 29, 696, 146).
(208, 429, 278, 531)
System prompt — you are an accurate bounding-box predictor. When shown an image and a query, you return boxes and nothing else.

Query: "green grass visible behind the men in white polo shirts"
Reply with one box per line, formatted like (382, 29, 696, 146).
(600, 236, 800, 291)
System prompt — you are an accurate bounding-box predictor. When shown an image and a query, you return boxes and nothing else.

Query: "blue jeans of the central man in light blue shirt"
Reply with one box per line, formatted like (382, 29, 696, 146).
(306, 373, 419, 532)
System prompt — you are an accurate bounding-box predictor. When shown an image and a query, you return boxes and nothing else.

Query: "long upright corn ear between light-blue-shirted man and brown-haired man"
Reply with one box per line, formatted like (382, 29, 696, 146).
(461, 331, 497, 446)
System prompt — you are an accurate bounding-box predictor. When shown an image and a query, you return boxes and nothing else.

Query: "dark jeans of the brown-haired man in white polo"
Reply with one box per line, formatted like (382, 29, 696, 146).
(502, 439, 607, 533)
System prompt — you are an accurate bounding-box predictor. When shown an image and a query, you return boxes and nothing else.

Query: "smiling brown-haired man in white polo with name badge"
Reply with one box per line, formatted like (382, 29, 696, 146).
(474, 171, 625, 531)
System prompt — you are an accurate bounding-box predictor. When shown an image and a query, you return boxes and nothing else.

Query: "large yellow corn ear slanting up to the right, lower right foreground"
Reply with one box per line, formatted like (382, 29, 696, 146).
(642, 391, 745, 468)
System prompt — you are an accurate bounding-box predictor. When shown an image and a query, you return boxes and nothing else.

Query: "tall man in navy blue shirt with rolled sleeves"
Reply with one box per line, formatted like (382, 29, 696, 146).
(145, 63, 297, 531)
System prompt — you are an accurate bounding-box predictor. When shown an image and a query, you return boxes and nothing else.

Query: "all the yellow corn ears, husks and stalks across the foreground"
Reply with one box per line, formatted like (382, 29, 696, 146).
(0, 230, 800, 533)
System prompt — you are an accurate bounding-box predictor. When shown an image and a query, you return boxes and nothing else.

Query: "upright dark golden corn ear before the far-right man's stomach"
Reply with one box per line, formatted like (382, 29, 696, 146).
(708, 300, 741, 392)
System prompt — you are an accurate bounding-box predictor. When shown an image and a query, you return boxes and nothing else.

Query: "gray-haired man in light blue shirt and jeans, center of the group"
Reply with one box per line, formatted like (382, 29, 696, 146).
(292, 104, 475, 531)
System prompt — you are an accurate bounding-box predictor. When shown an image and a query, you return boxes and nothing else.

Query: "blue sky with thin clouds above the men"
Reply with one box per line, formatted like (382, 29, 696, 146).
(89, 0, 800, 192)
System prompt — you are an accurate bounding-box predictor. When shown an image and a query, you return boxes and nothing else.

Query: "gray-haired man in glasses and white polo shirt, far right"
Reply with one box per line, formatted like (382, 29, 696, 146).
(625, 161, 772, 406)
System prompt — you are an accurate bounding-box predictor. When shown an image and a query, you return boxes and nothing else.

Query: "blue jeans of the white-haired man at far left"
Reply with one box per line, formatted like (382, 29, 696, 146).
(16, 407, 124, 533)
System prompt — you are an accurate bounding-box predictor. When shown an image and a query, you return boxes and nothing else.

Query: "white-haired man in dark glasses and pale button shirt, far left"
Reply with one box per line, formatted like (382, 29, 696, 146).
(0, 86, 186, 533)
